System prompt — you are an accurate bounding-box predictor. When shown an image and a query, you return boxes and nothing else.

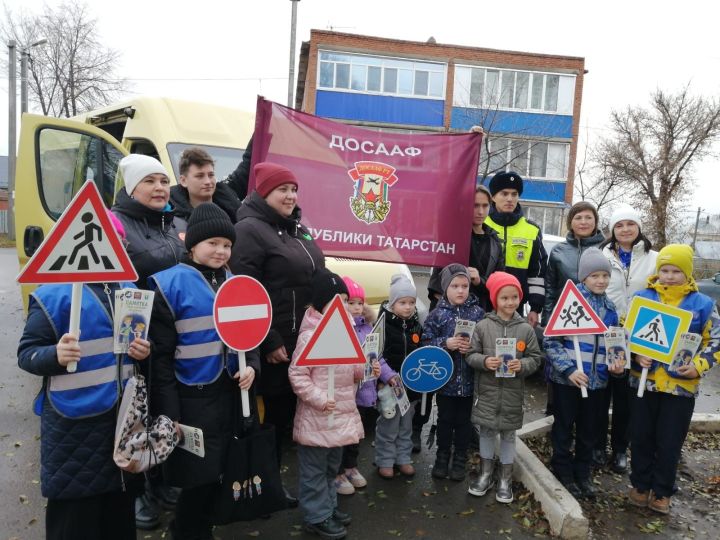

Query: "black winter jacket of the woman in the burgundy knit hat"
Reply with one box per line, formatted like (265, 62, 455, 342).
(230, 192, 325, 395)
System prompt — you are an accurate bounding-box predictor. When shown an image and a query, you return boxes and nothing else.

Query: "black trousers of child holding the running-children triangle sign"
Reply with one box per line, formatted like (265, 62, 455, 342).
(550, 382, 603, 481)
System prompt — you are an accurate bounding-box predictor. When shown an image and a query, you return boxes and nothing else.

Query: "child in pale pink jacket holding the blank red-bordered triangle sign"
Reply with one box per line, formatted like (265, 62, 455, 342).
(288, 268, 380, 539)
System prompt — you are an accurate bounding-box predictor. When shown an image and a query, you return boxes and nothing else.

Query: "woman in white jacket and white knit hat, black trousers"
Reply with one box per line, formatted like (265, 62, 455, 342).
(595, 204, 657, 472)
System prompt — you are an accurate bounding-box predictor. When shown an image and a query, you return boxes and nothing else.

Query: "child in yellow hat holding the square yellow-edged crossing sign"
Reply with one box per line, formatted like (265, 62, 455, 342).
(629, 244, 720, 514)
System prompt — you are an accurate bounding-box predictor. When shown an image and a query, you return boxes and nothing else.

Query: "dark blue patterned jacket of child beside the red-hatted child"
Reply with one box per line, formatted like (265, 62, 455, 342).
(422, 294, 485, 397)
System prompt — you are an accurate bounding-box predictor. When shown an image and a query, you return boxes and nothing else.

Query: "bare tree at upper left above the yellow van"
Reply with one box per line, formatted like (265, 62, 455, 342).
(0, 0, 127, 117)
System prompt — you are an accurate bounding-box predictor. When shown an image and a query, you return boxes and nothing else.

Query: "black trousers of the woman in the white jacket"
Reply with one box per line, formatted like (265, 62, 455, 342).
(595, 370, 632, 454)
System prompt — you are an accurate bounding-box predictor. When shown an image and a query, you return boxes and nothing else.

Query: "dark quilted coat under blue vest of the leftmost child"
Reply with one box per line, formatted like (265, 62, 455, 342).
(18, 283, 142, 499)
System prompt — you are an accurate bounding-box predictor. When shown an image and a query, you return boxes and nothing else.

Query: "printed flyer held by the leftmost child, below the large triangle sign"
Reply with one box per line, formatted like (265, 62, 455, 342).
(113, 289, 155, 354)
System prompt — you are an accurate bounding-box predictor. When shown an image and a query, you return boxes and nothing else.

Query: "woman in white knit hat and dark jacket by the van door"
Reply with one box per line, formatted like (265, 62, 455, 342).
(112, 154, 186, 529)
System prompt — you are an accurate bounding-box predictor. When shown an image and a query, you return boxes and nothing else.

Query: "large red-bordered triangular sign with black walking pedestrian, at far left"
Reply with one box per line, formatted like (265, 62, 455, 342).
(17, 181, 138, 284)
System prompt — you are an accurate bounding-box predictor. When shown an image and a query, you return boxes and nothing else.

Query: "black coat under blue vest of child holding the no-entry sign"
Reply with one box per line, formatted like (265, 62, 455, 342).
(150, 260, 260, 487)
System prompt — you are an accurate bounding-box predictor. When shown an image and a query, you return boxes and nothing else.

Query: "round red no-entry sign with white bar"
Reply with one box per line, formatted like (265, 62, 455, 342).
(213, 276, 272, 351)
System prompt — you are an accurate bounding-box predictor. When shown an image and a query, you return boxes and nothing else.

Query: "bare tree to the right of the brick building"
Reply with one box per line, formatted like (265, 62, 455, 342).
(594, 85, 720, 247)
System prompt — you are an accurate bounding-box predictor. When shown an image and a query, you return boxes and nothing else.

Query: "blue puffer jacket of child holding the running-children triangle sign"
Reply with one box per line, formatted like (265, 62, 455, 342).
(543, 283, 619, 390)
